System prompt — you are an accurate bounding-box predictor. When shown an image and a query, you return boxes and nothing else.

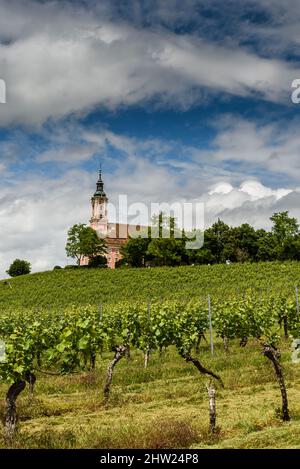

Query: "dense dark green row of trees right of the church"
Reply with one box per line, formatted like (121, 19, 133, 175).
(119, 211, 300, 267)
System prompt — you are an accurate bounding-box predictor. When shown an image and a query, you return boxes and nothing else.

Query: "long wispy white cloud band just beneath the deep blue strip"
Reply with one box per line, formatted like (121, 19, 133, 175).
(47, 115, 300, 184)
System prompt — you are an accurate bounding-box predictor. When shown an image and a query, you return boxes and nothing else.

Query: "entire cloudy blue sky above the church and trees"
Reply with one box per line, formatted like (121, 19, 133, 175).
(0, 0, 300, 278)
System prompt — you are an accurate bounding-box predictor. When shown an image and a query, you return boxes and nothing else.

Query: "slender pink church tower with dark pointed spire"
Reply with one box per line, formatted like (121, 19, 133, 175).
(90, 169, 108, 237)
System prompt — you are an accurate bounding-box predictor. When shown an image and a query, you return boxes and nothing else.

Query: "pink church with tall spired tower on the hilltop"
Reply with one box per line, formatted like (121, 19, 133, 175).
(80, 169, 140, 269)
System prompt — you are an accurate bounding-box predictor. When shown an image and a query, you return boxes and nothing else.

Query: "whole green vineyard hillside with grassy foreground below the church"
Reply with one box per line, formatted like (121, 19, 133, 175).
(0, 263, 300, 447)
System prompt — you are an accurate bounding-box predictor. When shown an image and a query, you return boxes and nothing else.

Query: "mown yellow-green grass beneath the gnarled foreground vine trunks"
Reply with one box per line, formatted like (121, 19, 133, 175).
(0, 334, 300, 448)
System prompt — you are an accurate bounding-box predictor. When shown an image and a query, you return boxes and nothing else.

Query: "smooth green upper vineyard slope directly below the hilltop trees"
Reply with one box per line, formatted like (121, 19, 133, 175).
(0, 262, 300, 309)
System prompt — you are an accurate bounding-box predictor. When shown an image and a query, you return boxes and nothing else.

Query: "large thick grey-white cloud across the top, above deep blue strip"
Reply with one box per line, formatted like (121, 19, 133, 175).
(0, 1, 300, 125)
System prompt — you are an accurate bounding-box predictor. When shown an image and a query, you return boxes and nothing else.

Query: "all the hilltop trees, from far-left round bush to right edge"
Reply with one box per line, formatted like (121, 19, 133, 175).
(7, 211, 300, 277)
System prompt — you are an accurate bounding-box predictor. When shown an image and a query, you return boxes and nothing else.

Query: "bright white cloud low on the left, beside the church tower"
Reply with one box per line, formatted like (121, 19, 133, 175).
(0, 171, 90, 277)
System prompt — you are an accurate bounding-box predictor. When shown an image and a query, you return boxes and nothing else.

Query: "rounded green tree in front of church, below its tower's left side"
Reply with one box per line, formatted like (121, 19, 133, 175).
(66, 224, 106, 265)
